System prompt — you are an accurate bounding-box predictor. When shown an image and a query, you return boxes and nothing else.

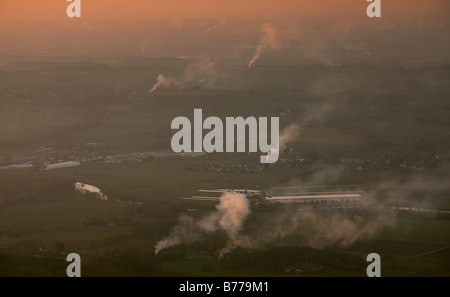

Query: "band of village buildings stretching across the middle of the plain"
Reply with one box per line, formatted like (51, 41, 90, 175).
(0, 143, 450, 173)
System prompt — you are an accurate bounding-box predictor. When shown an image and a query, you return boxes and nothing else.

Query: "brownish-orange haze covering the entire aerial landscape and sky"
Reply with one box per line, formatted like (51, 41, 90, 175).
(0, 0, 450, 276)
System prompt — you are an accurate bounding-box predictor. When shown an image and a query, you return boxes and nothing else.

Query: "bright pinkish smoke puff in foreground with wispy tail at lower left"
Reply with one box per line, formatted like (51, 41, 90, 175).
(155, 192, 250, 254)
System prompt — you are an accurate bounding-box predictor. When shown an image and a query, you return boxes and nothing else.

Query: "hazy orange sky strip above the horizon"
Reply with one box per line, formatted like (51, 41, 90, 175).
(0, 0, 450, 21)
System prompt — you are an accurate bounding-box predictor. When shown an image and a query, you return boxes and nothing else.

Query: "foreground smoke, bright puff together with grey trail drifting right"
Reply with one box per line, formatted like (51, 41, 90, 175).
(155, 165, 450, 253)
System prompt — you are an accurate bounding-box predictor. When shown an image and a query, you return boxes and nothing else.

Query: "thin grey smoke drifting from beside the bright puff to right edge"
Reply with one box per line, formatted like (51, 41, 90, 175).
(253, 166, 450, 248)
